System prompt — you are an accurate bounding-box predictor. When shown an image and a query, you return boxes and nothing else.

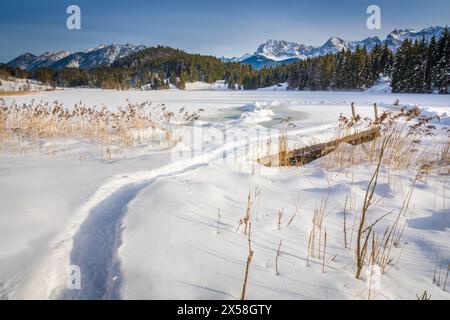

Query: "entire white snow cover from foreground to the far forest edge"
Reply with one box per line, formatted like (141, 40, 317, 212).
(0, 88, 450, 299)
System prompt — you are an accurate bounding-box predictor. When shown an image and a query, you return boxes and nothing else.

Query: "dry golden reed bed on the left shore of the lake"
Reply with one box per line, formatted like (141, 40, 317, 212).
(0, 98, 183, 155)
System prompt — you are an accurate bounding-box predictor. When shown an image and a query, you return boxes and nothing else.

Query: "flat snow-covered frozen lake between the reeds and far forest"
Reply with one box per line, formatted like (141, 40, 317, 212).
(4, 89, 450, 127)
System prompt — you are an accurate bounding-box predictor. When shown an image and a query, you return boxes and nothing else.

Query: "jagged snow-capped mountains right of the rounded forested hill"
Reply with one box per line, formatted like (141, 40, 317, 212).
(220, 26, 445, 69)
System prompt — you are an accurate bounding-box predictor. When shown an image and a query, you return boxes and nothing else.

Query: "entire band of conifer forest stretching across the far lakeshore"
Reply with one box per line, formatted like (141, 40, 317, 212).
(0, 29, 450, 94)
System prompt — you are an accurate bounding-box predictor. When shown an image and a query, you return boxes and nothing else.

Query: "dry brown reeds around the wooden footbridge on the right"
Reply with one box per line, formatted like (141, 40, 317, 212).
(322, 108, 444, 174)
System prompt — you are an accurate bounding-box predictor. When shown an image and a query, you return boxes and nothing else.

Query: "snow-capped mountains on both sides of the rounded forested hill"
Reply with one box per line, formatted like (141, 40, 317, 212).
(7, 26, 444, 70)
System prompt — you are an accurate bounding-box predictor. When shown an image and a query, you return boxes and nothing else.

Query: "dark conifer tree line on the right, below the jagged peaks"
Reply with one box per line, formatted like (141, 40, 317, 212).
(277, 29, 450, 94)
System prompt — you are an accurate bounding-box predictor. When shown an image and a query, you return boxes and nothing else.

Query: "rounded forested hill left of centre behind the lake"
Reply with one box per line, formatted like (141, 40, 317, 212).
(0, 46, 254, 90)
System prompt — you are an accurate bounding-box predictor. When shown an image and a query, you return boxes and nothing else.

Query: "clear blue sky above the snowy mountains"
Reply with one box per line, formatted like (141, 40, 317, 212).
(0, 0, 450, 62)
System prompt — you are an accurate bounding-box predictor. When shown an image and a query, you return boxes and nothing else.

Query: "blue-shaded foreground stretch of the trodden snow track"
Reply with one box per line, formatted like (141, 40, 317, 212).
(61, 182, 146, 300)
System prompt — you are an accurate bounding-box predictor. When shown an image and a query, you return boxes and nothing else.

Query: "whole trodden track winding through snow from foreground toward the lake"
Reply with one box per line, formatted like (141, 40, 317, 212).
(22, 125, 333, 299)
